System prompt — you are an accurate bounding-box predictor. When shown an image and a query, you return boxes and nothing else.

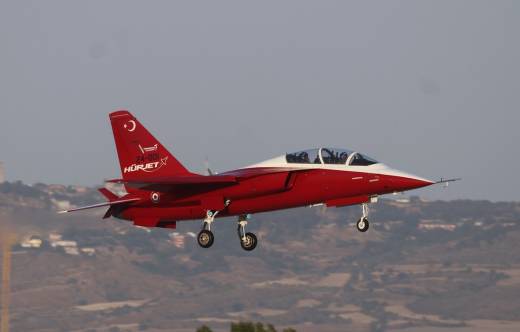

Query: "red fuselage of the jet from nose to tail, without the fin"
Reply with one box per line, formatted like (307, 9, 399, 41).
(117, 167, 433, 221)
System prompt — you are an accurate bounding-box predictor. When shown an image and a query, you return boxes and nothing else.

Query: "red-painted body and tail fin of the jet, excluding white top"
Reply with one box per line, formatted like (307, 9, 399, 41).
(75, 111, 433, 228)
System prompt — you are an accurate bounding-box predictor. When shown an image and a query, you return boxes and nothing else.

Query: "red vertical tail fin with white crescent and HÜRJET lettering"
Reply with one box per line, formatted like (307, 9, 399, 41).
(110, 111, 191, 180)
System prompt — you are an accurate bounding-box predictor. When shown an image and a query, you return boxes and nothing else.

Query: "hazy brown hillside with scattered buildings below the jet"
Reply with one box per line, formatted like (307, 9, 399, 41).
(0, 183, 520, 332)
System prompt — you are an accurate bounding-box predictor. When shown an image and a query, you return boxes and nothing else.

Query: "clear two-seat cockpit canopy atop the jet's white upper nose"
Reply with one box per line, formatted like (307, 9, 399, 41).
(285, 148, 378, 166)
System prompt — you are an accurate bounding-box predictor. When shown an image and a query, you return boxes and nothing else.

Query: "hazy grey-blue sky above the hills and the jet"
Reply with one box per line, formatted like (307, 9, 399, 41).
(0, 0, 520, 200)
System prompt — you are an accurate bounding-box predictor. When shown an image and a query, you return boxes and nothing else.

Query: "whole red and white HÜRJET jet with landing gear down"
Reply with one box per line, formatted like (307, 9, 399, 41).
(61, 111, 456, 251)
